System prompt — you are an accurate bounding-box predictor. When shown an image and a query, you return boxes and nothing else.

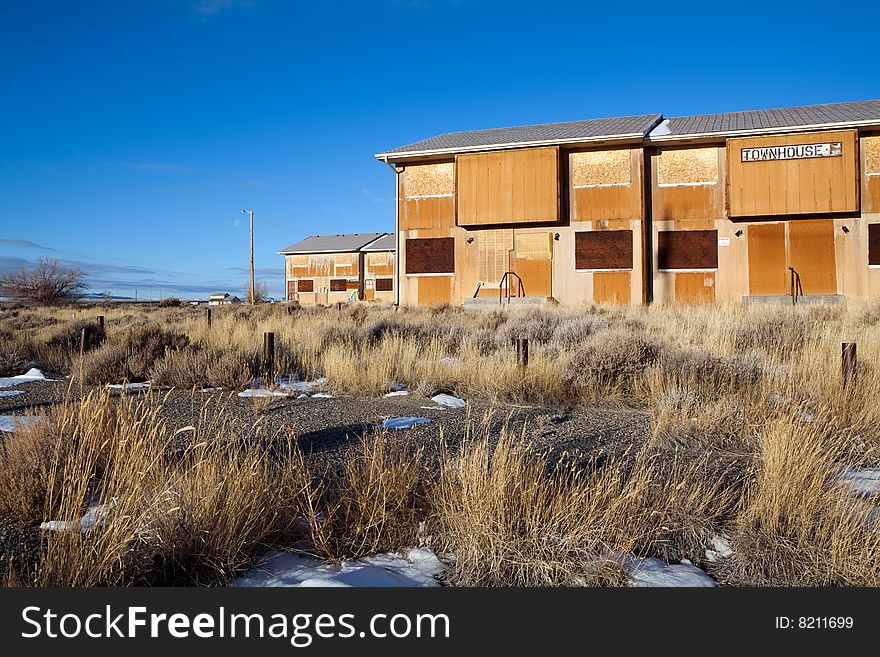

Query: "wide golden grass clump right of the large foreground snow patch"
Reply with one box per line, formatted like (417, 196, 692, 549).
(429, 433, 735, 586)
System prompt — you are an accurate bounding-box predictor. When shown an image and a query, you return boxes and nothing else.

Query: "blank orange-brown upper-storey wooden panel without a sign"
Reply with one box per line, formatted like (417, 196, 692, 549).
(455, 147, 560, 226)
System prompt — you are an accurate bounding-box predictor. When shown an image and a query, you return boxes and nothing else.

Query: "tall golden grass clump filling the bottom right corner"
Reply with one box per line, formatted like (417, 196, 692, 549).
(718, 416, 880, 586)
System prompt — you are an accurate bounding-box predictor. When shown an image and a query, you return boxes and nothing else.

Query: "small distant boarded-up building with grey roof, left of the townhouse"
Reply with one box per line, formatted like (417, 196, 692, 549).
(279, 233, 395, 305)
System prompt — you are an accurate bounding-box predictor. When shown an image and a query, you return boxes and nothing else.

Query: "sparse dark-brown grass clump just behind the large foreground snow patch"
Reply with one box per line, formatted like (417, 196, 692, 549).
(307, 432, 425, 560)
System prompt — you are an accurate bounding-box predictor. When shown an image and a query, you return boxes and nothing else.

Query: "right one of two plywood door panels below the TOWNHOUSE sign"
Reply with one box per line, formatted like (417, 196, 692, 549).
(788, 219, 837, 294)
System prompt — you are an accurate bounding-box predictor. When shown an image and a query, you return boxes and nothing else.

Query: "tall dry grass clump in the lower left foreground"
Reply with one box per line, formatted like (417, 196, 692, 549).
(13, 394, 303, 586)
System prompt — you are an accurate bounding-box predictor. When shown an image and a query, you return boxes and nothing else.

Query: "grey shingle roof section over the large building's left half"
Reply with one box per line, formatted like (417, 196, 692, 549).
(376, 114, 663, 157)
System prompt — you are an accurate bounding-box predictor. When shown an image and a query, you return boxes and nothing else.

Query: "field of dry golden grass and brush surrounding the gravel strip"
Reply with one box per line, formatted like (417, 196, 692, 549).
(0, 304, 880, 585)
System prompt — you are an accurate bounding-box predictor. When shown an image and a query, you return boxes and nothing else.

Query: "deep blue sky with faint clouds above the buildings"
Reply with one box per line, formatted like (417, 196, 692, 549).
(0, 0, 880, 298)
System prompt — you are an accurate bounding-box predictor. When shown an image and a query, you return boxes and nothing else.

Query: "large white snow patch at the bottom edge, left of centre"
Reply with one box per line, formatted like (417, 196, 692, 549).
(229, 548, 446, 588)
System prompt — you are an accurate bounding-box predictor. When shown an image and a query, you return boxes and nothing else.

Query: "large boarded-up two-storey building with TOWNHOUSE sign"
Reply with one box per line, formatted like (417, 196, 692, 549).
(376, 100, 880, 305)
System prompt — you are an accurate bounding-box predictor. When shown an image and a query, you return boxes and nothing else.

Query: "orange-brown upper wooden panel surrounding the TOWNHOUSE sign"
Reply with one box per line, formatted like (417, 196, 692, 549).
(727, 130, 859, 217)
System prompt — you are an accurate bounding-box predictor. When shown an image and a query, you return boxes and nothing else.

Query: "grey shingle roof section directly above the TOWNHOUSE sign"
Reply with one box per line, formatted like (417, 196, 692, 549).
(651, 100, 880, 138)
